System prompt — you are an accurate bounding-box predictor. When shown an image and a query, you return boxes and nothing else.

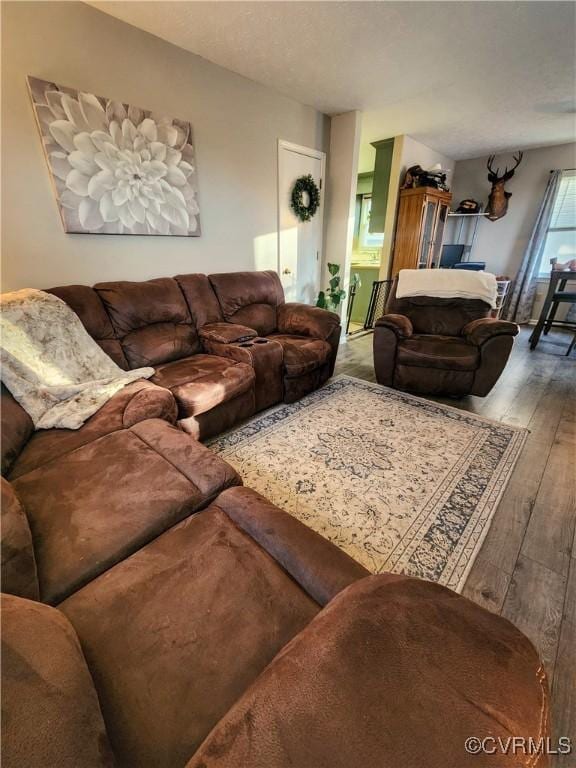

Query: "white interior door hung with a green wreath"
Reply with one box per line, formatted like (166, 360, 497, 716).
(278, 141, 326, 304)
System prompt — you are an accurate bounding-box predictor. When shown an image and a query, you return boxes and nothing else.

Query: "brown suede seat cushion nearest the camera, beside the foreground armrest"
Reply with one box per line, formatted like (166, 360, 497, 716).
(60, 488, 319, 768)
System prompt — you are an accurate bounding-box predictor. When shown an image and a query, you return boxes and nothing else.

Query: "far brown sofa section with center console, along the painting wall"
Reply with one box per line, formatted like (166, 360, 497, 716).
(50, 272, 341, 439)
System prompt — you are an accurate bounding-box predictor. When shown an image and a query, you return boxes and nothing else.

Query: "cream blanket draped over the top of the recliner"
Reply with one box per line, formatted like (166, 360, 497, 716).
(396, 269, 497, 309)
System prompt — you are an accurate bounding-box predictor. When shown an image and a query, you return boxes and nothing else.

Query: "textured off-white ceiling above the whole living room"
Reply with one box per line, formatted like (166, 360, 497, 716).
(90, 0, 576, 170)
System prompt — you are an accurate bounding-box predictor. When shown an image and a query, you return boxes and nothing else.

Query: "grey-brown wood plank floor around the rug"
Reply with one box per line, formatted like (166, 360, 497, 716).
(336, 329, 576, 756)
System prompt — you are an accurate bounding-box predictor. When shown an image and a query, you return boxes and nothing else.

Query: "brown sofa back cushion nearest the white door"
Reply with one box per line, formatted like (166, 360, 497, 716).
(209, 271, 284, 336)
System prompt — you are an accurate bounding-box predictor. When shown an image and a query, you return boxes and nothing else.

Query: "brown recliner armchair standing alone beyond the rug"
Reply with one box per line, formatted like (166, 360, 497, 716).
(374, 281, 519, 397)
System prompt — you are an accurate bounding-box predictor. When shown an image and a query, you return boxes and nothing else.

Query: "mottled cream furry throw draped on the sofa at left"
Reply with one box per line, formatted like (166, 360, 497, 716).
(0, 288, 154, 429)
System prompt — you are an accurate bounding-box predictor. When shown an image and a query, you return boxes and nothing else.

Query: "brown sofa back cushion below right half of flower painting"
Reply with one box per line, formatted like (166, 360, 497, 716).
(94, 277, 201, 368)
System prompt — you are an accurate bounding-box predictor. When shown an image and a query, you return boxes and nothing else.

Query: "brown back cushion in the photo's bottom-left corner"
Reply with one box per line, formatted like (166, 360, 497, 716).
(1, 595, 115, 768)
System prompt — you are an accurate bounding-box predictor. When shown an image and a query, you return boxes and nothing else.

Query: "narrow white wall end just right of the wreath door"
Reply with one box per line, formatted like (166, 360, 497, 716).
(321, 112, 361, 317)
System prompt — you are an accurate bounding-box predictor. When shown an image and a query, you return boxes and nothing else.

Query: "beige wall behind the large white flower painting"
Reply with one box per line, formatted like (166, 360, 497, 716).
(1, 2, 330, 290)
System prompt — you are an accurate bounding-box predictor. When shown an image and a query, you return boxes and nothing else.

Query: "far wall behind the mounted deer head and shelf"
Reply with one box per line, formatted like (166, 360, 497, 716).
(452, 143, 576, 278)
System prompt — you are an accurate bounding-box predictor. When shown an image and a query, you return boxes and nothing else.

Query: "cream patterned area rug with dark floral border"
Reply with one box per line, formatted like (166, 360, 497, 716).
(210, 376, 527, 591)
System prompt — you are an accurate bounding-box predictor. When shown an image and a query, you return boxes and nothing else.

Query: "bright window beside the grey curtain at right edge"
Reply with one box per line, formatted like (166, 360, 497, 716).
(539, 171, 576, 277)
